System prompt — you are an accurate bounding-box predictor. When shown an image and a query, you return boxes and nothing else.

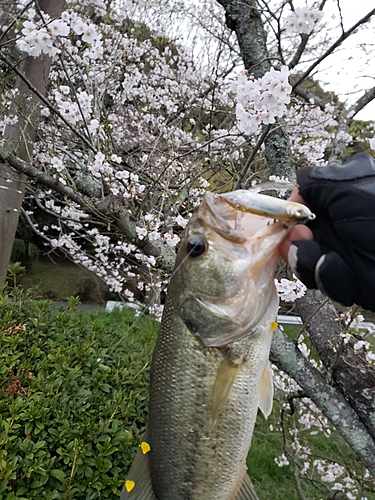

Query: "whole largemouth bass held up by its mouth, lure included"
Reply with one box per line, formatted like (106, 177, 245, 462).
(121, 191, 310, 500)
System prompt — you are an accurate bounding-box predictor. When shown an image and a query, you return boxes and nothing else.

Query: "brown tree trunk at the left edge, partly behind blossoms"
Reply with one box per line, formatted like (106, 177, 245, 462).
(0, 0, 65, 286)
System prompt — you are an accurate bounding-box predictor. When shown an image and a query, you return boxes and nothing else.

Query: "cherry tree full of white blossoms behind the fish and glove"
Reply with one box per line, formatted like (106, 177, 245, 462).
(0, 0, 375, 498)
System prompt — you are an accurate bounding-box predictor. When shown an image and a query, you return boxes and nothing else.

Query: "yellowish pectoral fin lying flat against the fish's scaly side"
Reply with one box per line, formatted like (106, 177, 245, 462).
(211, 357, 240, 423)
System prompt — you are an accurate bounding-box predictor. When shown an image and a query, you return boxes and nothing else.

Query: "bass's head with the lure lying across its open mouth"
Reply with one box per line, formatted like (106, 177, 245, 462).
(176, 190, 315, 347)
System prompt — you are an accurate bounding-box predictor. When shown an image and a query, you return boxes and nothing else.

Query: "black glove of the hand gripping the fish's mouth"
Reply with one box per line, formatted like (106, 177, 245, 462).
(292, 153, 375, 311)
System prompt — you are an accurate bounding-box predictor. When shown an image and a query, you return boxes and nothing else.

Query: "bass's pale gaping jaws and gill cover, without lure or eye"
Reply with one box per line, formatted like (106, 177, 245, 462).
(180, 192, 290, 347)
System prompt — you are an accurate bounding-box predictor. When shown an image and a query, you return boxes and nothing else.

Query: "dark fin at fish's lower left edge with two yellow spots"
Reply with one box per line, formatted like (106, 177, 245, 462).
(120, 436, 157, 500)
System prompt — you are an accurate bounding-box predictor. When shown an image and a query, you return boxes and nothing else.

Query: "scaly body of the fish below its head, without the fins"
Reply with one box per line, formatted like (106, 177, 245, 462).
(148, 302, 272, 500)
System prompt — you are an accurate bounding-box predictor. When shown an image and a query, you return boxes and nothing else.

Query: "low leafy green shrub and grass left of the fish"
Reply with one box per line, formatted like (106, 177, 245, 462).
(0, 289, 158, 500)
